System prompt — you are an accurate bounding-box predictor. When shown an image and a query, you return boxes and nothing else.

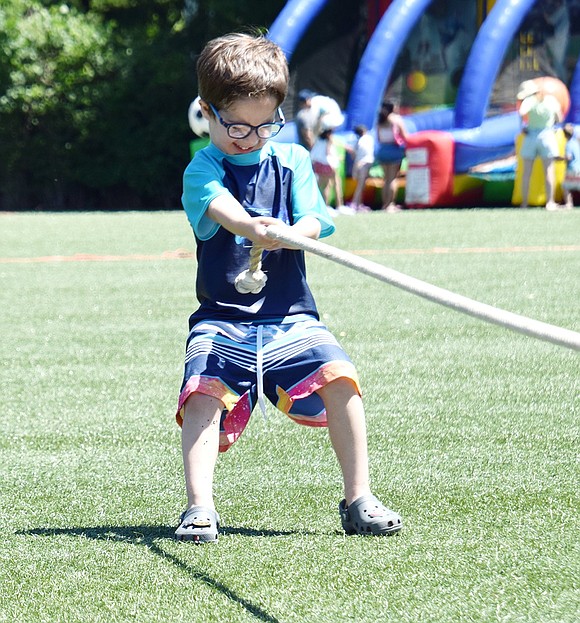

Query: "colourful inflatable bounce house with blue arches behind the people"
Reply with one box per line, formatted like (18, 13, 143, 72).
(269, 0, 580, 207)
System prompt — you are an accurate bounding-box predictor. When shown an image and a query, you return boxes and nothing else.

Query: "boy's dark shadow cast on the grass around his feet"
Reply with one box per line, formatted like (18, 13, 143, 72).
(17, 525, 314, 623)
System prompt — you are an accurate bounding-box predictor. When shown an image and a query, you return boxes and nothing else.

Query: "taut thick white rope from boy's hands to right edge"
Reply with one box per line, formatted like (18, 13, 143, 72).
(266, 225, 580, 350)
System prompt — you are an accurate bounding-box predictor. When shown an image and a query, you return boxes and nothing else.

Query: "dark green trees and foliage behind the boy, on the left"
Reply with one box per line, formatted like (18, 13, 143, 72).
(0, 0, 284, 210)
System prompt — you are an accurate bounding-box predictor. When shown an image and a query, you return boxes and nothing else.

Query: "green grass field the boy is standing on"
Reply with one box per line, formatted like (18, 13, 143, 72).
(0, 209, 580, 623)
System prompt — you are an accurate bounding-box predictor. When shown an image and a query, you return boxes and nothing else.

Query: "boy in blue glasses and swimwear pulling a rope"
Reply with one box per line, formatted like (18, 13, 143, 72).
(175, 34, 402, 543)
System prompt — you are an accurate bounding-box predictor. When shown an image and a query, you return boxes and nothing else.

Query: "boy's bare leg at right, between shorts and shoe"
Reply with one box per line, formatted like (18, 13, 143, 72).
(318, 378, 370, 504)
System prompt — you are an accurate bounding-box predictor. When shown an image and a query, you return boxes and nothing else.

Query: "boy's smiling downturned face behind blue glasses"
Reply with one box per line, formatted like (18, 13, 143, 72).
(200, 97, 278, 156)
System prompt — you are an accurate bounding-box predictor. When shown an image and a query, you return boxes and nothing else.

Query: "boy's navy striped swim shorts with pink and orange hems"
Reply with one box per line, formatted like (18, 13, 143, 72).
(176, 315, 360, 452)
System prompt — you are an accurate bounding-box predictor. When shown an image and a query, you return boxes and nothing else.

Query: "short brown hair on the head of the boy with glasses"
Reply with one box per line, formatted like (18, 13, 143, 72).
(197, 33, 288, 109)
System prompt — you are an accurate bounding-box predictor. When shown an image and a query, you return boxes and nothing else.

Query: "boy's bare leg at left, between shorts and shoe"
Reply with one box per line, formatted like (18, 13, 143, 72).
(181, 393, 224, 508)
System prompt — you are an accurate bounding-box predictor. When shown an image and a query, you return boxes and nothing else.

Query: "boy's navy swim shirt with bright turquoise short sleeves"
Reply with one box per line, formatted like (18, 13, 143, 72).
(182, 141, 334, 324)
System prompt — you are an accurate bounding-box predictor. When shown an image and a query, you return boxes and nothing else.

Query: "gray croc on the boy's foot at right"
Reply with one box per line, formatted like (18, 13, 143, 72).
(338, 495, 403, 536)
